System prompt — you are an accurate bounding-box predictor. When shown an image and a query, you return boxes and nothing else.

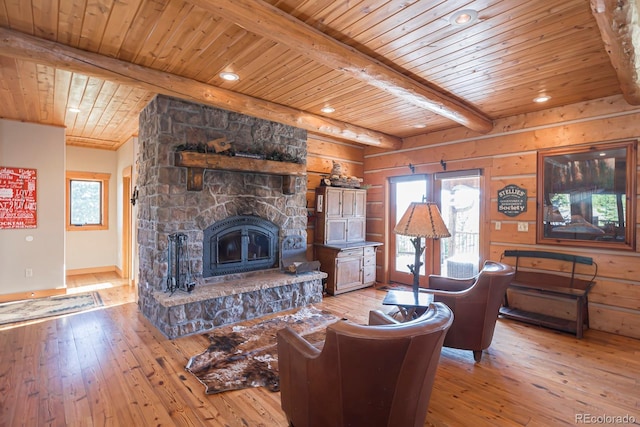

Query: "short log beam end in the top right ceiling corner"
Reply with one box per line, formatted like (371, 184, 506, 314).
(591, 0, 640, 105)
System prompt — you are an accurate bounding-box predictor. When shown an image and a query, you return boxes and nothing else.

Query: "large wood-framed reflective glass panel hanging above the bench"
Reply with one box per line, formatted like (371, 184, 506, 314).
(537, 141, 636, 250)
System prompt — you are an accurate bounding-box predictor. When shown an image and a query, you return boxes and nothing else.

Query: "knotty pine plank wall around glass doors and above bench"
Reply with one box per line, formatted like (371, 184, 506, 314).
(360, 97, 640, 338)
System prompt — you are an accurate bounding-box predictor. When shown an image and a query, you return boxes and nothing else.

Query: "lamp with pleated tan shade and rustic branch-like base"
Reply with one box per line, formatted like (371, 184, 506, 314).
(393, 202, 451, 299)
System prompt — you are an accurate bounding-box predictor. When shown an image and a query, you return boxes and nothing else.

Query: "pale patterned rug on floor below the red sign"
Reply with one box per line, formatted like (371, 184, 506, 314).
(0, 292, 103, 325)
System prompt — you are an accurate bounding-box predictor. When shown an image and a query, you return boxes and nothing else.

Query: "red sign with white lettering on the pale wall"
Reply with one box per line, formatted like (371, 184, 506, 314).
(0, 166, 37, 229)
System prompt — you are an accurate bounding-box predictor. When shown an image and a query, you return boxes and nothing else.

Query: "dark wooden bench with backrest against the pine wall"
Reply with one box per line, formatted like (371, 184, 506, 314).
(500, 250, 598, 338)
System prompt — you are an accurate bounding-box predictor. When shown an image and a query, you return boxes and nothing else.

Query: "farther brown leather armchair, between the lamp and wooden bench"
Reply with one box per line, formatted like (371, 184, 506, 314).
(420, 261, 515, 362)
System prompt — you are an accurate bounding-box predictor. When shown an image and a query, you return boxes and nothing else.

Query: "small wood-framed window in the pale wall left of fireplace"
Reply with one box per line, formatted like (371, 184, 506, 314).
(66, 172, 111, 231)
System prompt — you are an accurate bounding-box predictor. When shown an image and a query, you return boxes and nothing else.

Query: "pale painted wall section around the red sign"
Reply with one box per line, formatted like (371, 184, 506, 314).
(0, 119, 65, 294)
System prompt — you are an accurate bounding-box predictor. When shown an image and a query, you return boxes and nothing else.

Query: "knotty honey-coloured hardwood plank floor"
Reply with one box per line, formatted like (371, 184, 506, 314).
(0, 280, 640, 427)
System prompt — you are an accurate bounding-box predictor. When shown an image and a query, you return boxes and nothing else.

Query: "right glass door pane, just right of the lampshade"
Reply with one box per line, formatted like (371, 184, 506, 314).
(440, 176, 480, 278)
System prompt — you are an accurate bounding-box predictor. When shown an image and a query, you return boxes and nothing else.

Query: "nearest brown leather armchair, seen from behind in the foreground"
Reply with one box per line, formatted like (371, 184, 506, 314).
(278, 304, 453, 427)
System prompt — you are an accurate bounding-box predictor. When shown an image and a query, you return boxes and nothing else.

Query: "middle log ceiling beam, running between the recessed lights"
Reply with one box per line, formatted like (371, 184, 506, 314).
(188, 0, 493, 133)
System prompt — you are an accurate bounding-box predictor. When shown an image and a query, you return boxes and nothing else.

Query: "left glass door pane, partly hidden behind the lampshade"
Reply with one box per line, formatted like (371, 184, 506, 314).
(395, 179, 427, 276)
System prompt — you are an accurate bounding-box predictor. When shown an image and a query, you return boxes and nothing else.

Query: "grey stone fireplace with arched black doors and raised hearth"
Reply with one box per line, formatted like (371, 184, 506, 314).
(137, 95, 326, 338)
